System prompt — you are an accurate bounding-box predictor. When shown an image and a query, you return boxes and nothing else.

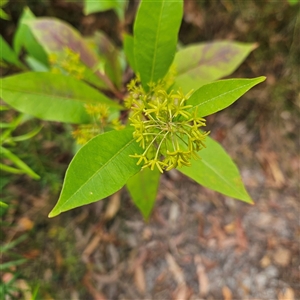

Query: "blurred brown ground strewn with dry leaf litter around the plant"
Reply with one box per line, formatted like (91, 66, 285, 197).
(1, 0, 300, 300)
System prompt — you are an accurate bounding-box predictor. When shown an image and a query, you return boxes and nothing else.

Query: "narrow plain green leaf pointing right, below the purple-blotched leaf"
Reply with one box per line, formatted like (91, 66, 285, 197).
(186, 76, 266, 117)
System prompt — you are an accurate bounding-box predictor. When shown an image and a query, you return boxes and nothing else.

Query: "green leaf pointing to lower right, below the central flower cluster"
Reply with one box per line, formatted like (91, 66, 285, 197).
(178, 137, 253, 204)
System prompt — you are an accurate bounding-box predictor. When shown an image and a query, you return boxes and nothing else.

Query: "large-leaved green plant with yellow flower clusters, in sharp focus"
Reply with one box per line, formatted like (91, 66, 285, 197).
(1, 0, 265, 219)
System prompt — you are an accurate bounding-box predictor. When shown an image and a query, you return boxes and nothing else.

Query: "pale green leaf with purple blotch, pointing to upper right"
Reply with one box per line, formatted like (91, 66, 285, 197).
(174, 41, 257, 93)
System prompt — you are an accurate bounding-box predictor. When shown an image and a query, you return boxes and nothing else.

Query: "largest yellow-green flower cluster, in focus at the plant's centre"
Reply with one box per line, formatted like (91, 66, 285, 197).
(125, 79, 209, 173)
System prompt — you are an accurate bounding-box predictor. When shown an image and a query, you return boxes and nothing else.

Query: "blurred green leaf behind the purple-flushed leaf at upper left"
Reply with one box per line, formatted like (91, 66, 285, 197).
(13, 7, 48, 66)
